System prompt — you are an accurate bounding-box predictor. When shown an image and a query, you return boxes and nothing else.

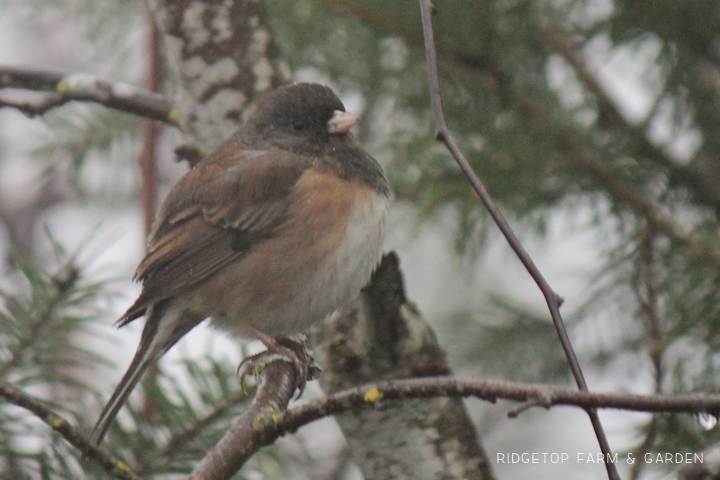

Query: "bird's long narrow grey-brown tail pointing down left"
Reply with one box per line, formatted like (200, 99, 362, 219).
(90, 309, 202, 445)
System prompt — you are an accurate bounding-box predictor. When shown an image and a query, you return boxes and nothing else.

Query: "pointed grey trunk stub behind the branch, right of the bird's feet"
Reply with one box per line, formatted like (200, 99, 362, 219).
(318, 253, 493, 480)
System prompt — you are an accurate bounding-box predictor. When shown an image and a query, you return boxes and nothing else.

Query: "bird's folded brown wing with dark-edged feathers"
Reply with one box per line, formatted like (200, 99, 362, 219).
(118, 142, 312, 326)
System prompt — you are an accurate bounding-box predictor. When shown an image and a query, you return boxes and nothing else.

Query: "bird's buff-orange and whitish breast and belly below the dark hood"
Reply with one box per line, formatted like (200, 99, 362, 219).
(210, 169, 388, 336)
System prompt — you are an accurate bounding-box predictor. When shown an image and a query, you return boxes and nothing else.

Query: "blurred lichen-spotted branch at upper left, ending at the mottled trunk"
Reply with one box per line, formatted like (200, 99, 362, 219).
(0, 65, 177, 125)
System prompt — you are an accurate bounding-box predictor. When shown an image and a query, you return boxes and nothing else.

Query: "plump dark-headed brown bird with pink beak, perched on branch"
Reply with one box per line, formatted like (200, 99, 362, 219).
(90, 83, 391, 445)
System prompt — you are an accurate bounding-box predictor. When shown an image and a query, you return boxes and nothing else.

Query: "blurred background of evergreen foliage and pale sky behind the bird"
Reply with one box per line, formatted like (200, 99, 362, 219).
(0, 0, 720, 480)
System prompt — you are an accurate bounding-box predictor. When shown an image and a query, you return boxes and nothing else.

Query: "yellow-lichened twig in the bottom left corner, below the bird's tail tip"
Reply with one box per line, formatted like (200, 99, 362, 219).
(0, 380, 141, 480)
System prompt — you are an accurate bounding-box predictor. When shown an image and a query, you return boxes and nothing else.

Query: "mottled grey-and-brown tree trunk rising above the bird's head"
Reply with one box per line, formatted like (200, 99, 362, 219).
(150, 0, 284, 150)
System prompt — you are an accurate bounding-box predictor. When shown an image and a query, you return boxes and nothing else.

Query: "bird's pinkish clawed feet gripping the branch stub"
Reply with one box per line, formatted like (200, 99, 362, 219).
(238, 326, 320, 399)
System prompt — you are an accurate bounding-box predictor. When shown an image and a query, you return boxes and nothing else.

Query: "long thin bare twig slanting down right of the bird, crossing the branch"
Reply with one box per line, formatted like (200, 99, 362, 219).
(419, 0, 620, 480)
